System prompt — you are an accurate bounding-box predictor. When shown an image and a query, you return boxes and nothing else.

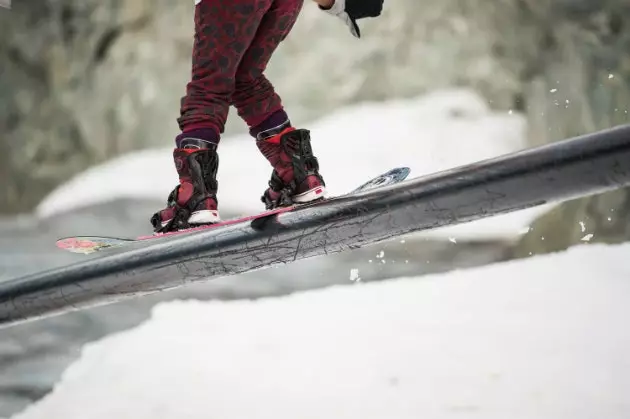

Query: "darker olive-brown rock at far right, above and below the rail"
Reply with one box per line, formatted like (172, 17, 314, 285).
(505, 0, 630, 256)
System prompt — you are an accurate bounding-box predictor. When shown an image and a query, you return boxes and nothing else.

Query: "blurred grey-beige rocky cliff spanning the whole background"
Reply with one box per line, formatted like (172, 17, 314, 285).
(0, 0, 630, 249)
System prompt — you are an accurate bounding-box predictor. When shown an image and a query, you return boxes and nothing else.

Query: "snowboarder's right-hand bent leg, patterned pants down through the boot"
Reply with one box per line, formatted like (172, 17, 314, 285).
(232, 0, 326, 209)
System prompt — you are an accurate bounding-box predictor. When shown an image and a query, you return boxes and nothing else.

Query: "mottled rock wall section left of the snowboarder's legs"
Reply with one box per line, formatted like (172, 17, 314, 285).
(0, 0, 193, 213)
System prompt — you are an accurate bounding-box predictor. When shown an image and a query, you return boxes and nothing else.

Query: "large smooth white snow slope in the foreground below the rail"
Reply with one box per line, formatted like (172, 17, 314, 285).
(13, 244, 630, 419)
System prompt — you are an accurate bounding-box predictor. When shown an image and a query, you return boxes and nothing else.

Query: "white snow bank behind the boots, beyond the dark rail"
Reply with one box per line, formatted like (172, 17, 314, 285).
(36, 90, 547, 238)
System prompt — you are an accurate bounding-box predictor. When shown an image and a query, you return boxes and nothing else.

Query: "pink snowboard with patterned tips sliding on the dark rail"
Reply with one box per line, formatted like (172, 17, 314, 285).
(56, 167, 411, 254)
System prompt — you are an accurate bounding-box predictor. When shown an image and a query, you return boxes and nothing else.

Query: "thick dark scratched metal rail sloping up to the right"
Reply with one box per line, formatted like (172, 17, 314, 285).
(0, 125, 630, 326)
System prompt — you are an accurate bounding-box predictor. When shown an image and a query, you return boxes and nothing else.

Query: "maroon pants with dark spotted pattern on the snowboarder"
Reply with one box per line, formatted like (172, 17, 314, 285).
(177, 0, 303, 133)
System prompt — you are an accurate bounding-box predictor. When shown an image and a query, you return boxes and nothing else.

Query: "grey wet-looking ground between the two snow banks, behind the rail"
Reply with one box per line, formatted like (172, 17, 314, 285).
(0, 200, 507, 417)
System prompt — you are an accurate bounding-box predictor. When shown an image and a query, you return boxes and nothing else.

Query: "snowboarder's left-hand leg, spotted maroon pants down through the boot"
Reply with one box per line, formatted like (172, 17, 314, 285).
(151, 0, 273, 232)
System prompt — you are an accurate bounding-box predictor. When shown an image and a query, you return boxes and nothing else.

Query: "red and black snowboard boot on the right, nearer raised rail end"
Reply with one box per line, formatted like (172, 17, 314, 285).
(256, 124, 326, 209)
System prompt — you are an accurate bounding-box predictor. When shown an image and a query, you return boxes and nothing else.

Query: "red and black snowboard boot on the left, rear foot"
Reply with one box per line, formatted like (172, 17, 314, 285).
(151, 138, 220, 233)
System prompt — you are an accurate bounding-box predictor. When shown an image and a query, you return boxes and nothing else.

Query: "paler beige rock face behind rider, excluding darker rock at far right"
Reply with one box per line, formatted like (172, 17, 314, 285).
(0, 0, 517, 213)
